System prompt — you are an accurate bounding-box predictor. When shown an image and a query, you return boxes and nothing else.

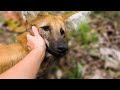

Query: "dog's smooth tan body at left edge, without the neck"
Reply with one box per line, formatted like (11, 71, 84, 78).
(0, 43, 28, 73)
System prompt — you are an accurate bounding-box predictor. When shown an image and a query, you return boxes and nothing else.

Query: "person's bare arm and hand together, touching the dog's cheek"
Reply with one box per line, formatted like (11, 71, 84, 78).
(0, 26, 46, 79)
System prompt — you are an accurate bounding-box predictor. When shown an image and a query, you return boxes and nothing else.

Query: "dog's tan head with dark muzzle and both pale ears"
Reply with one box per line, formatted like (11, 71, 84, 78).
(22, 11, 89, 57)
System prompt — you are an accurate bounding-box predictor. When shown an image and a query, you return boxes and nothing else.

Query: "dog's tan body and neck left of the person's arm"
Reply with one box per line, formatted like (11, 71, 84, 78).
(0, 32, 29, 73)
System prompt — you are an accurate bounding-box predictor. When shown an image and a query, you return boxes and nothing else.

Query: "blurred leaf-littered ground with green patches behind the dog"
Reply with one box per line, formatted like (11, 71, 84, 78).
(0, 11, 120, 79)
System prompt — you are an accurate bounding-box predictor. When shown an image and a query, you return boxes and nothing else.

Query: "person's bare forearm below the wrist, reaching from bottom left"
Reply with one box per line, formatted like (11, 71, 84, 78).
(0, 49, 45, 79)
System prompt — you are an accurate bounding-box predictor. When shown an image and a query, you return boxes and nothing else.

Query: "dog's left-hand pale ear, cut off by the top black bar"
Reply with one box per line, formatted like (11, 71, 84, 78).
(22, 11, 43, 22)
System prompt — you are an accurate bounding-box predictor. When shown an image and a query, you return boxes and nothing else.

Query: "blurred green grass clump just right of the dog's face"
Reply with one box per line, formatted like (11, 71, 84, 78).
(68, 22, 98, 47)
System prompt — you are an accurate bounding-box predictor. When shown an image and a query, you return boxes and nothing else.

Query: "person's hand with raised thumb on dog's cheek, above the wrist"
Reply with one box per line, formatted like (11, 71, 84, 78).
(27, 26, 46, 51)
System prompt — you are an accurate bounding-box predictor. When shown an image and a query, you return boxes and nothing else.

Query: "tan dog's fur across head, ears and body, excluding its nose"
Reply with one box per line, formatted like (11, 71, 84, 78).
(0, 11, 89, 76)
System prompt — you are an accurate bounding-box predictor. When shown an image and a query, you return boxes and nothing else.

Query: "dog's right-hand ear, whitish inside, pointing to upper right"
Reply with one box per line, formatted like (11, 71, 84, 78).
(62, 11, 90, 30)
